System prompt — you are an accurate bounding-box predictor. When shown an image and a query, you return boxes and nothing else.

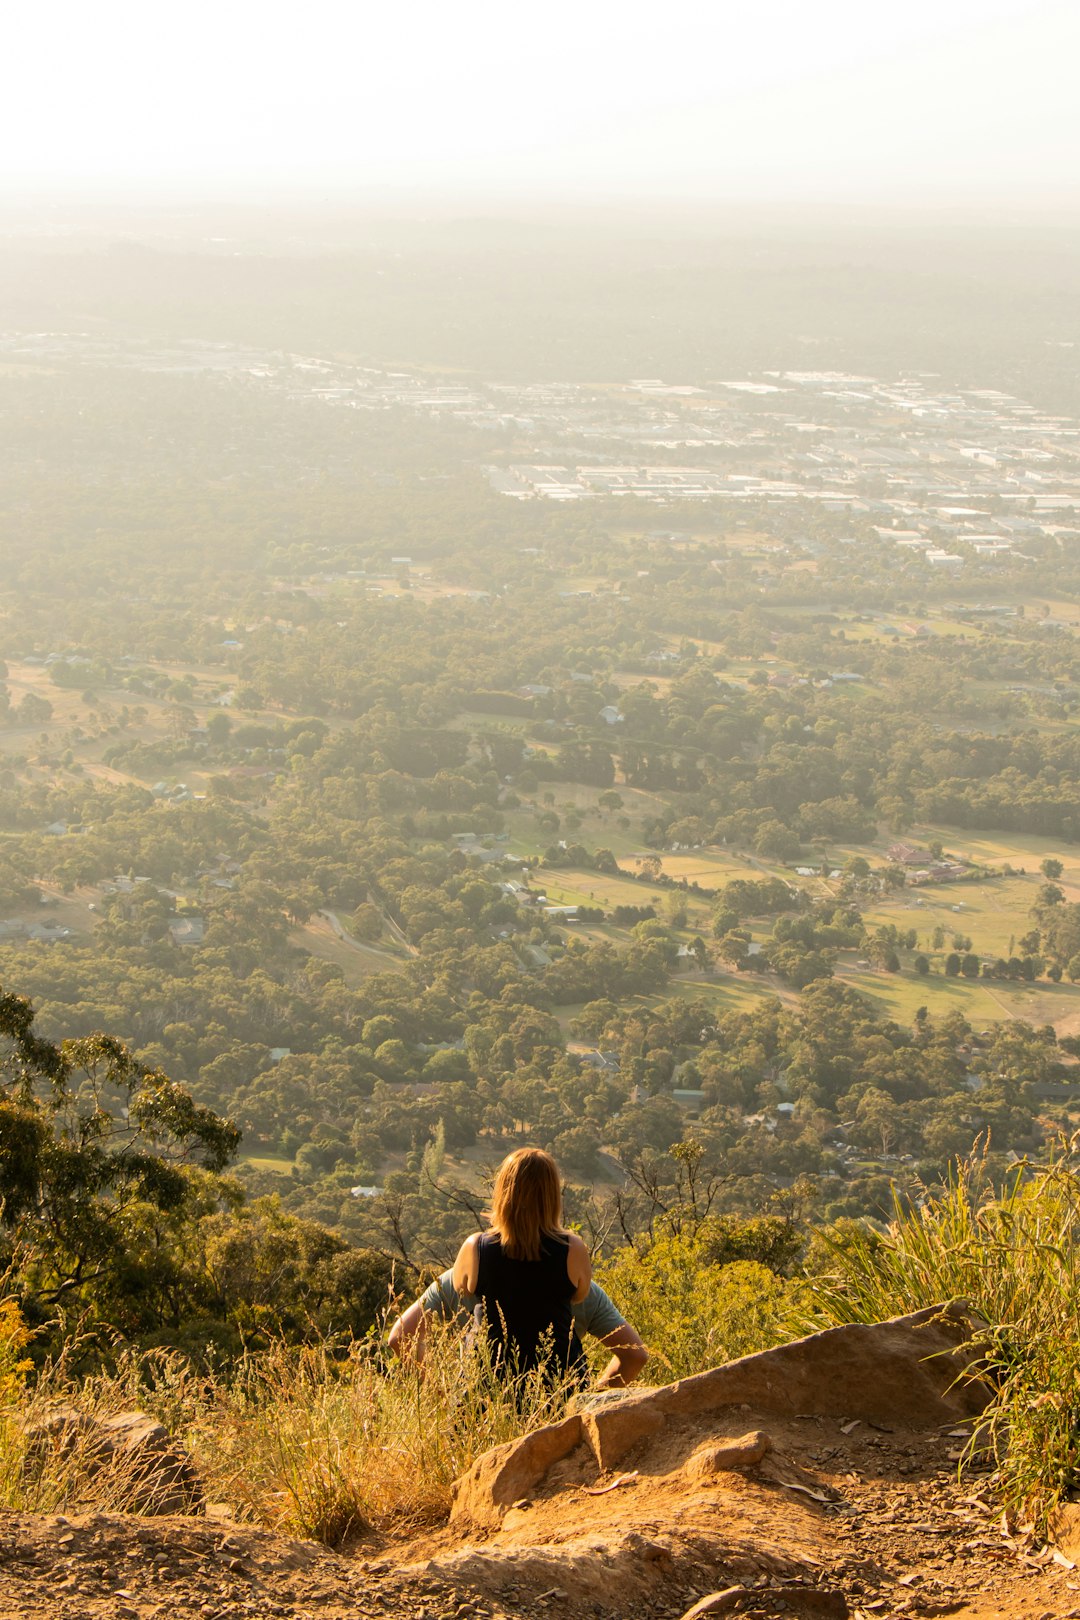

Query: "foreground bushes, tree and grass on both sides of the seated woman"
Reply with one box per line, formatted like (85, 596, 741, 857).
(0, 996, 1080, 1542)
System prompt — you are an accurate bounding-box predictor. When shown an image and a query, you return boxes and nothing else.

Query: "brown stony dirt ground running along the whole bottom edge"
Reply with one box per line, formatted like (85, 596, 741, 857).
(0, 1411, 1080, 1620)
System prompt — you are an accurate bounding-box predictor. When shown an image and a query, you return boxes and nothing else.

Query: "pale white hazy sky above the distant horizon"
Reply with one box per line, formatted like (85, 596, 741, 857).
(8, 0, 1080, 206)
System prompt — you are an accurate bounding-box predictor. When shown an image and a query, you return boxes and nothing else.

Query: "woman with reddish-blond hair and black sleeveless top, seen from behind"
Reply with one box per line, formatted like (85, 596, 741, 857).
(453, 1147, 593, 1380)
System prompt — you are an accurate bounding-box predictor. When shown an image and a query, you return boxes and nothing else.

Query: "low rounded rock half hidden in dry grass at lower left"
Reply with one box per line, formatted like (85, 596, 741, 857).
(23, 1406, 202, 1513)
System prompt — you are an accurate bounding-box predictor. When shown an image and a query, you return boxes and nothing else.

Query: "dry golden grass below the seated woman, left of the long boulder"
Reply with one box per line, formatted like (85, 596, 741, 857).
(0, 1324, 582, 1545)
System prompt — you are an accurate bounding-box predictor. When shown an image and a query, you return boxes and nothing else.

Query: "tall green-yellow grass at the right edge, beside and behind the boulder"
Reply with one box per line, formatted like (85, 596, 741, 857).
(800, 1137, 1080, 1531)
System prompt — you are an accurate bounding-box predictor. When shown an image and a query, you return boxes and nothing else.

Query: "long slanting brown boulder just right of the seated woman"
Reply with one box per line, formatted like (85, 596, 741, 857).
(450, 1306, 988, 1528)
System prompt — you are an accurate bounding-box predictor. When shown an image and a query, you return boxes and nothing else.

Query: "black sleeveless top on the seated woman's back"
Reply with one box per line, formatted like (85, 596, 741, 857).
(476, 1233, 586, 1377)
